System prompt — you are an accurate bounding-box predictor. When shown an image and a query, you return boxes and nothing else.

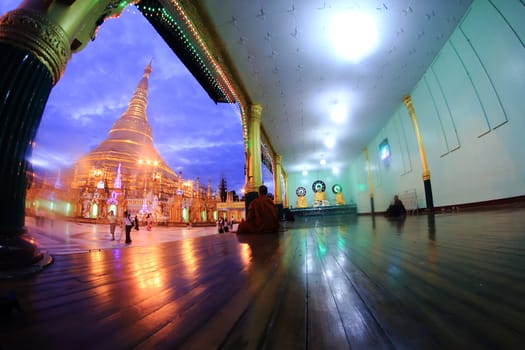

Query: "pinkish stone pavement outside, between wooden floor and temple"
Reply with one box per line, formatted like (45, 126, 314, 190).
(25, 217, 218, 255)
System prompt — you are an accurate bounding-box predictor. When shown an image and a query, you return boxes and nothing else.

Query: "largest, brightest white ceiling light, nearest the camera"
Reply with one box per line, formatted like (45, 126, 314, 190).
(330, 11, 377, 63)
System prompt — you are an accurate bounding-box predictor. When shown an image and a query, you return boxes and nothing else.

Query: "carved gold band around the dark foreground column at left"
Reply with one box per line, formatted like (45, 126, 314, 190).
(0, 9, 71, 84)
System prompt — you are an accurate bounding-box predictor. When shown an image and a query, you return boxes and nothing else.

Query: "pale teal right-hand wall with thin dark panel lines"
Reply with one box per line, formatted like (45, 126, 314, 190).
(348, 0, 525, 212)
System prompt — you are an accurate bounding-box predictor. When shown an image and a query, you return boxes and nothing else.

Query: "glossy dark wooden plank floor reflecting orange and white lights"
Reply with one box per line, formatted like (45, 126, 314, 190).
(0, 209, 525, 350)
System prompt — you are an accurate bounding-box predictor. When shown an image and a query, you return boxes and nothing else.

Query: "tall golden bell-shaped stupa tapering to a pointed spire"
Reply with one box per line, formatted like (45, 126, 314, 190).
(70, 62, 177, 211)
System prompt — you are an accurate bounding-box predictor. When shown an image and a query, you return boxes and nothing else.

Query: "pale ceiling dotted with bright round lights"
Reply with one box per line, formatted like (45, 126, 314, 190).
(188, 0, 471, 173)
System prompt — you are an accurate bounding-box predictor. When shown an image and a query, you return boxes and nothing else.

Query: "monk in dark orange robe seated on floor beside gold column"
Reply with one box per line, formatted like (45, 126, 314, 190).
(237, 185, 279, 234)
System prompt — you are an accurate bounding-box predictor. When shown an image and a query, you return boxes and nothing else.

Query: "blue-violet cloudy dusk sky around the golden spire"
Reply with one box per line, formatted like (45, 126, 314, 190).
(0, 0, 273, 193)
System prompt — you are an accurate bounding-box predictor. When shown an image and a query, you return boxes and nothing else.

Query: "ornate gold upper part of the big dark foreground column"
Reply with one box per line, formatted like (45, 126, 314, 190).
(0, 0, 134, 85)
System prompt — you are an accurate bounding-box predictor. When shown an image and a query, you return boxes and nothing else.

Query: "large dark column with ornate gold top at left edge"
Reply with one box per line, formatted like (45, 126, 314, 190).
(0, 0, 137, 271)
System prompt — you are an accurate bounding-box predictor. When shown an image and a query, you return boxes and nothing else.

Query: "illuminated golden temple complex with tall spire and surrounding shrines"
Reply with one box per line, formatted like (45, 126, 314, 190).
(26, 63, 217, 223)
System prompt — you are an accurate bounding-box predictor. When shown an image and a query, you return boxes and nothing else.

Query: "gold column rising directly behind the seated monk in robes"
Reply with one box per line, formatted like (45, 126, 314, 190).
(244, 104, 262, 213)
